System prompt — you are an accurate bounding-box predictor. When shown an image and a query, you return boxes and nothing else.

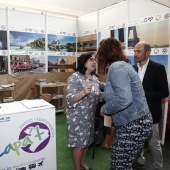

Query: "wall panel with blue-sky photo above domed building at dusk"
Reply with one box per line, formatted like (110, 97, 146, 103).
(47, 16, 77, 72)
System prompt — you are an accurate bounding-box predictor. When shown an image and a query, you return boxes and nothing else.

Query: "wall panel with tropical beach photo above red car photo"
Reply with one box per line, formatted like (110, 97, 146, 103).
(9, 10, 47, 74)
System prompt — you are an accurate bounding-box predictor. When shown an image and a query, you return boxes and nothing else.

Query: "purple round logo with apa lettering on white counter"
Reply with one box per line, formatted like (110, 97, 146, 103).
(0, 122, 51, 157)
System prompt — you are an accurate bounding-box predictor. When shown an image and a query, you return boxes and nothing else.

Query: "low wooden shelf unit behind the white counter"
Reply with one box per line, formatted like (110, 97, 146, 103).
(35, 82, 66, 113)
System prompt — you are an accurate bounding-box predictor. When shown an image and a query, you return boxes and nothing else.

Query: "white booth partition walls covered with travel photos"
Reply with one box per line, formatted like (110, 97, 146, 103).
(0, 0, 170, 143)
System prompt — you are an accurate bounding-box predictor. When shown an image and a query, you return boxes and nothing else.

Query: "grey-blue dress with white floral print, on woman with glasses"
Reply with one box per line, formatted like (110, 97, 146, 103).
(66, 72, 100, 148)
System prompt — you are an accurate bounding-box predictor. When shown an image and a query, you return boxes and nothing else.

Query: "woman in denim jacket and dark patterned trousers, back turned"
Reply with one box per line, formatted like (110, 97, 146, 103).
(97, 38, 152, 170)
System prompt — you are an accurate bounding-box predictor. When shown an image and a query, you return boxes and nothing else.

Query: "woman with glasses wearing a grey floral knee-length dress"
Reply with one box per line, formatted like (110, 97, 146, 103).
(66, 52, 100, 170)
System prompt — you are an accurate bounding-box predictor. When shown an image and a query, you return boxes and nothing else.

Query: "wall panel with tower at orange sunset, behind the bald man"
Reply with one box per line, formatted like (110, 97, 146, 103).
(128, 13, 170, 71)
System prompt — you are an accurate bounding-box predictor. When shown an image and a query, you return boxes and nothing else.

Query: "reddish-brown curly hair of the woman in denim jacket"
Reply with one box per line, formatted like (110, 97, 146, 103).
(97, 37, 129, 68)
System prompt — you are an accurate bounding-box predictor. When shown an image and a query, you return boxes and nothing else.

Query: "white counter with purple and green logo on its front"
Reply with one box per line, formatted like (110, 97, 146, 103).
(0, 99, 57, 170)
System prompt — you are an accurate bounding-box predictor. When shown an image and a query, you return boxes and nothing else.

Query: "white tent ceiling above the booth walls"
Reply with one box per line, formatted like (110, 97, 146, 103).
(0, 0, 170, 17)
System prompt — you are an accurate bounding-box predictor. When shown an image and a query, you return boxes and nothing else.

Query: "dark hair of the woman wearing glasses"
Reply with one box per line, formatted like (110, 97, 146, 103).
(76, 52, 95, 75)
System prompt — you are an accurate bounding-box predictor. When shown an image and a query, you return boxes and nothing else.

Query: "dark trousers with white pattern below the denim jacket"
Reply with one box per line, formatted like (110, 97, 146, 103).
(111, 115, 152, 170)
